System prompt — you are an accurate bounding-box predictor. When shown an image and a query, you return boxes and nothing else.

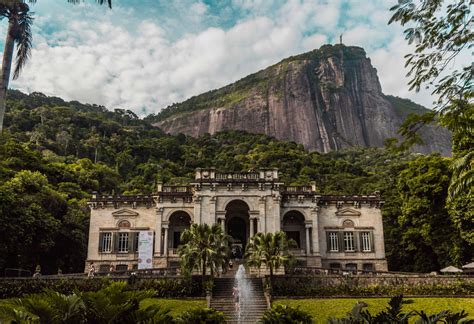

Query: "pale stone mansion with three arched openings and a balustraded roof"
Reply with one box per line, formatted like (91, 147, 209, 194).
(86, 168, 387, 271)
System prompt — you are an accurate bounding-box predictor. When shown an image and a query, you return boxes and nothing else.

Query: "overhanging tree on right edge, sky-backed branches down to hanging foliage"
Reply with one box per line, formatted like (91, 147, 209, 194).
(389, 0, 474, 201)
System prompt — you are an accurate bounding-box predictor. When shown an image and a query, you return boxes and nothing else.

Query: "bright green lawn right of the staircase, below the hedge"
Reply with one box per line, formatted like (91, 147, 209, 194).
(273, 298, 474, 323)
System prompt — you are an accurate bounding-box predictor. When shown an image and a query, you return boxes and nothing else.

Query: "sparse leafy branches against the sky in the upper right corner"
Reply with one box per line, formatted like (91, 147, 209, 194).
(389, 0, 474, 104)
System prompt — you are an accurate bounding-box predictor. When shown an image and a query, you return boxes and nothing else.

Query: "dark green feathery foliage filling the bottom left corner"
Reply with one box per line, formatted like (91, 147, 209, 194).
(0, 282, 172, 324)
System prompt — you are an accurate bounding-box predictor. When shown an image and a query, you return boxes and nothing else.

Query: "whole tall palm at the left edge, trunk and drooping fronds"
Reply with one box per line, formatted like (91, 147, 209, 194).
(0, 0, 112, 135)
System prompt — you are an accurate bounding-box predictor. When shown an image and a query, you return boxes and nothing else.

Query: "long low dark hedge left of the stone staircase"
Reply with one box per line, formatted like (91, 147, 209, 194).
(0, 276, 204, 299)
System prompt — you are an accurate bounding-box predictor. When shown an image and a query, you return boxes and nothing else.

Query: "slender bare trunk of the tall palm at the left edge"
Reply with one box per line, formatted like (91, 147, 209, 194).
(0, 18, 18, 135)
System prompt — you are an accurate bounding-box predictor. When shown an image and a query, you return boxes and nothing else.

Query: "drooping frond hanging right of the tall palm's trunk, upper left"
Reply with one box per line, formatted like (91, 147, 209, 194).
(13, 6, 33, 79)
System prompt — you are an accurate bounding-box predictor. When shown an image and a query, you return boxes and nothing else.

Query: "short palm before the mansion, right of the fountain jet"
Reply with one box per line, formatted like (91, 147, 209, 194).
(245, 231, 294, 280)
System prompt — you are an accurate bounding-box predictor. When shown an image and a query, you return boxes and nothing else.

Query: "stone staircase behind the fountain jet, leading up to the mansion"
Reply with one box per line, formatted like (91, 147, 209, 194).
(211, 277, 267, 324)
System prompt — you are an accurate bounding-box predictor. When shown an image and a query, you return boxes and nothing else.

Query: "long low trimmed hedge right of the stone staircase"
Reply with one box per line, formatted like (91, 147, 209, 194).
(272, 276, 474, 297)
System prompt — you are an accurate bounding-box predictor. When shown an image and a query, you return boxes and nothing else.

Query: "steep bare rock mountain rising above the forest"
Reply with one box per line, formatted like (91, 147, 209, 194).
(147, 45, 450, 155)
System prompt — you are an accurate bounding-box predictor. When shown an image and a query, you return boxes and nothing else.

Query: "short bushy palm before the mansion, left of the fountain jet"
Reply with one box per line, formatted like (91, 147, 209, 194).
(178, 224, 229, 279)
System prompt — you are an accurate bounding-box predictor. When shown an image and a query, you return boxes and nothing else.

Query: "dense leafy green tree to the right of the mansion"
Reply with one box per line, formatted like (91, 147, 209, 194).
(398, 156, 469, 272)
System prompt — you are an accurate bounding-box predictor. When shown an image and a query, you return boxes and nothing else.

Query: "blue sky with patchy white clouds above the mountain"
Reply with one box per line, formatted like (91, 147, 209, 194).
(0, 0, 460, 116)
